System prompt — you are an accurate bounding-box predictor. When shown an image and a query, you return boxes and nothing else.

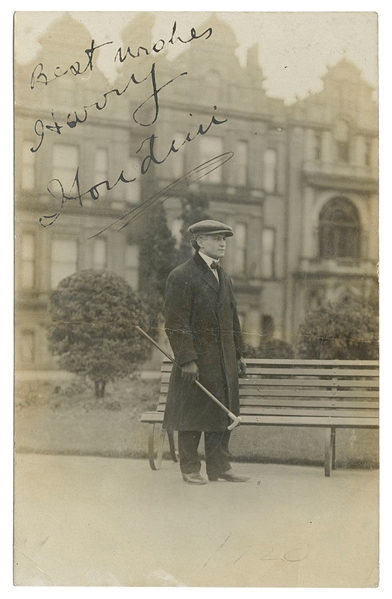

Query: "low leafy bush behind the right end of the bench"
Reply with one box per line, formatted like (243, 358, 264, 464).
(296, 299, 379, 360)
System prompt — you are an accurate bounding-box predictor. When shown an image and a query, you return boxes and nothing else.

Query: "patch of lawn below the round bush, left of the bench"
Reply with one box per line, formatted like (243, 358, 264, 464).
(15, 377, 159, 457)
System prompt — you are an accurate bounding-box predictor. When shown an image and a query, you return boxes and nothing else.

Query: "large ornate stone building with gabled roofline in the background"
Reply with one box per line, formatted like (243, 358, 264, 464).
(15, 13, 378, 369)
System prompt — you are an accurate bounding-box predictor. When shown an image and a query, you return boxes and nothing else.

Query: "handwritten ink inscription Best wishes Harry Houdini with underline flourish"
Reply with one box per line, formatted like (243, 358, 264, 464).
(30, 21, 227, 235)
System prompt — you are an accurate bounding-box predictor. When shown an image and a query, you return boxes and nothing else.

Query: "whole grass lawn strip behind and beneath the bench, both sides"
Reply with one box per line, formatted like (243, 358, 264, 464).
(15, 376, 378, 468)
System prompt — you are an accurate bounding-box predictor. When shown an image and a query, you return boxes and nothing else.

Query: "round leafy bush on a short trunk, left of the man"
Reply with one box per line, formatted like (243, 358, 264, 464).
(48, 270, 148, 397)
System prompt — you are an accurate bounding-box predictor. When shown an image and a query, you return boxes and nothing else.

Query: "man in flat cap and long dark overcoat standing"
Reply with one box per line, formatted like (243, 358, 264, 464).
(163, 220, 249, 484)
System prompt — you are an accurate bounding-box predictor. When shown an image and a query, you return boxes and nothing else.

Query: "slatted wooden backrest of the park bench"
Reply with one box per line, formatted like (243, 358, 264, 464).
(158, 359, 379, 419)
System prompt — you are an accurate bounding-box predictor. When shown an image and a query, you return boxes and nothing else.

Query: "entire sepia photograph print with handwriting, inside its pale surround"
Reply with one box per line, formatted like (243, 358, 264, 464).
(13, 6, 380, 589)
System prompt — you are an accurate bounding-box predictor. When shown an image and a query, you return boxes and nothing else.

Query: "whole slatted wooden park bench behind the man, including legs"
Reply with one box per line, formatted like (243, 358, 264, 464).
(141, 359, 379, 476)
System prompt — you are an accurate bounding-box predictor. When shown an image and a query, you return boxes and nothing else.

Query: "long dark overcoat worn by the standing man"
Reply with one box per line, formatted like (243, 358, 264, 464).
(163, 253, 243, 431)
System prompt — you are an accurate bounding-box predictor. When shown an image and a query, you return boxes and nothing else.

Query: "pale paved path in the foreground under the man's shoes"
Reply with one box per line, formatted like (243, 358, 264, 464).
(15, 454, 378, 587)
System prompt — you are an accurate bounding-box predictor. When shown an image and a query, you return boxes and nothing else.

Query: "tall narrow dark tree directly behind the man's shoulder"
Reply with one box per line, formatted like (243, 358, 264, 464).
(140, 204, 178, 337)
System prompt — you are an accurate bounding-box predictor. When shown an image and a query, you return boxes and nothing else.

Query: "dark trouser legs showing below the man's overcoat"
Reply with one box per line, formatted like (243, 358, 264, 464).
(178, 429, 231, 476)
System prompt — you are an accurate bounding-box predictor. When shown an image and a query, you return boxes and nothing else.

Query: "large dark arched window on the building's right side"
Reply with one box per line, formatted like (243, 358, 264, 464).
(319, 198, 361, 258)
